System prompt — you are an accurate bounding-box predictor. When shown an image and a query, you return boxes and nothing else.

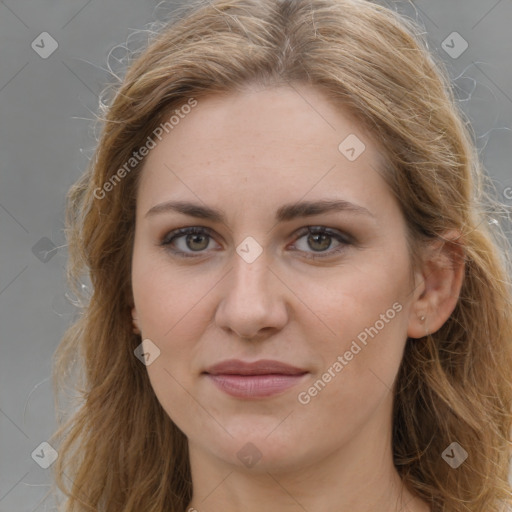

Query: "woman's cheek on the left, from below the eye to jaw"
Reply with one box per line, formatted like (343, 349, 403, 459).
(132, 251, 221, 435)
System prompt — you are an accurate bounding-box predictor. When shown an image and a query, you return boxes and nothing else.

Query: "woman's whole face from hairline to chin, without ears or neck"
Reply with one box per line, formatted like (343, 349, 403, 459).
(132, 85, 424, 471)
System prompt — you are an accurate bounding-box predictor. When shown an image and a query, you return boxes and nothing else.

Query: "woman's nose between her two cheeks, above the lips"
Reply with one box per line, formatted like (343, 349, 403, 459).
(215, 249, 290, 340)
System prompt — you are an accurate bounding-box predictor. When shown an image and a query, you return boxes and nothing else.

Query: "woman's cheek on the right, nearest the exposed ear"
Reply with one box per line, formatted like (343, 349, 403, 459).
(300, 250, 409, 384)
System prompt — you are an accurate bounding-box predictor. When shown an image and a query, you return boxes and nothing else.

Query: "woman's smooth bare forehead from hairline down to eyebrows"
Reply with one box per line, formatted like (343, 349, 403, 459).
(134, 85, 390, 220)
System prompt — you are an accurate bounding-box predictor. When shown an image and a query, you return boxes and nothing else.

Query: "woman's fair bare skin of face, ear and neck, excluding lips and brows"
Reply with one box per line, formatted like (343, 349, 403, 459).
(132, 84, 463, 512)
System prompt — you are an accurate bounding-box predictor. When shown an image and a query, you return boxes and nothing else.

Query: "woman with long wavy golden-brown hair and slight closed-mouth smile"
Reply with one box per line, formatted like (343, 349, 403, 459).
(51, 0, 512, 512)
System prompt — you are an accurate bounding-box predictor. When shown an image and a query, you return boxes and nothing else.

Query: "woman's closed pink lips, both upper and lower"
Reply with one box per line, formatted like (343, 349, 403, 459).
(203, 359, 309, 399)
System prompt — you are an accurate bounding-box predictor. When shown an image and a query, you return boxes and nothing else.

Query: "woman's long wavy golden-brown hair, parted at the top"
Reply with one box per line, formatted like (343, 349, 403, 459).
(51, 0, 512, 512)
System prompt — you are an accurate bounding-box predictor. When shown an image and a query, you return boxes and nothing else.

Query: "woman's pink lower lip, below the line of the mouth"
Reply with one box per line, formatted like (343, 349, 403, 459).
(207, 373, 306, 398)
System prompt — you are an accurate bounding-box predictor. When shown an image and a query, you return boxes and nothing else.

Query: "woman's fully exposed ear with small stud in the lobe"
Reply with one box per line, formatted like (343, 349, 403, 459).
(407, 231, 465, 338)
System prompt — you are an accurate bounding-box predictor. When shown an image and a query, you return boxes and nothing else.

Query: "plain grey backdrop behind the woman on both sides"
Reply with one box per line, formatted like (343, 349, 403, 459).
(0, 0, 512, 512)
